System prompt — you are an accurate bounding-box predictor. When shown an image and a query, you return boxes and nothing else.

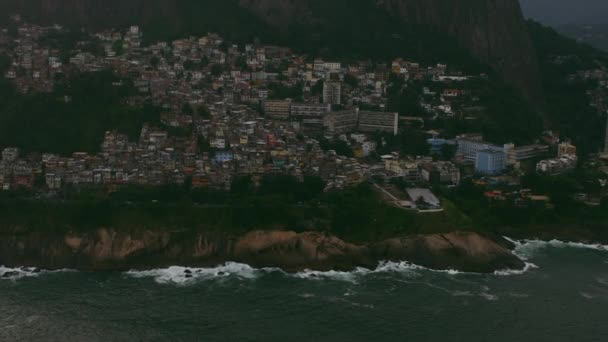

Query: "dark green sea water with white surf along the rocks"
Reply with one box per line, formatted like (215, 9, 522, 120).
(0, 242, 608, 342)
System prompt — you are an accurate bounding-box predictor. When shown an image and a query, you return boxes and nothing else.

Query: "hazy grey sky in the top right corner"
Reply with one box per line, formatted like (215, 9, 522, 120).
(520, 0, 608, 25)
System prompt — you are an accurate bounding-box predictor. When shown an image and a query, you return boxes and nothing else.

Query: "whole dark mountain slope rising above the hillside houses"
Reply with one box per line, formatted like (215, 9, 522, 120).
(0, 0, 542, 100)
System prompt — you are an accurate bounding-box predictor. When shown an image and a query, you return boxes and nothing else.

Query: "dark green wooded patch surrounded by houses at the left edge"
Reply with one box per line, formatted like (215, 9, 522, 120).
(0, 71, 160, 154)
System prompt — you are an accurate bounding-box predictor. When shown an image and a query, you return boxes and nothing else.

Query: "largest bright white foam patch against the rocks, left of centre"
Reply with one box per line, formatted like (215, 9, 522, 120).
(126, 262, 282, 285)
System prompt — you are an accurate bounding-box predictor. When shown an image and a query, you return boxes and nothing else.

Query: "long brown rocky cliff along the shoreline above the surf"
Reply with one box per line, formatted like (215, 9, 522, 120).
(0, 228, 523, 272)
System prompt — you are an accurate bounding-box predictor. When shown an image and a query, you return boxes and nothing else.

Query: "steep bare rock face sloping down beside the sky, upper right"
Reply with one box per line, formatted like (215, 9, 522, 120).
(378, 0, 542, 100)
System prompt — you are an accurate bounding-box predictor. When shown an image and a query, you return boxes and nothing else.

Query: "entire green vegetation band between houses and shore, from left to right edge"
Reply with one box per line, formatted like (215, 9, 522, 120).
(0, 170, 608, 242)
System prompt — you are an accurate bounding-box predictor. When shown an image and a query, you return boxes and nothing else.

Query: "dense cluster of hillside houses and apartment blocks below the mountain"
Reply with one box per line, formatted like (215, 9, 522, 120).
(0, 17, 605, 208)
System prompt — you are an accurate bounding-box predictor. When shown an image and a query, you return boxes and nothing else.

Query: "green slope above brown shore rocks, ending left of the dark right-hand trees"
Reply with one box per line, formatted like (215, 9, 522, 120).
(0, 176, 471, 241)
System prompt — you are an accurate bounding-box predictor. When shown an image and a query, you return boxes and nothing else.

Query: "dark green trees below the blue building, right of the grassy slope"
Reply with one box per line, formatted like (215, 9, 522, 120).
(437, 171, 608, 240)
